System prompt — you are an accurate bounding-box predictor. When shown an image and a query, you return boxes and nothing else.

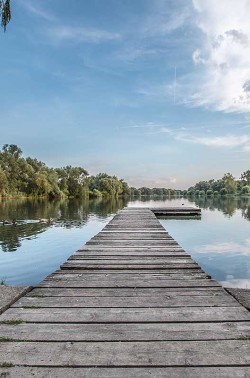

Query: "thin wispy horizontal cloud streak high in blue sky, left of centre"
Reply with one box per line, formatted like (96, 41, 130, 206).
(47, 25, 121, 43)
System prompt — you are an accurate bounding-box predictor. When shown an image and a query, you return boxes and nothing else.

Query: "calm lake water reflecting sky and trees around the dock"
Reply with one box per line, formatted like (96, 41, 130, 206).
(0, 198, 250, 288)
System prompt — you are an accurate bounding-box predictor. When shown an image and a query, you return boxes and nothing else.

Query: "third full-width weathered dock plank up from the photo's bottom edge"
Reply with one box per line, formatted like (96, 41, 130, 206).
(0, 322, 250, 342)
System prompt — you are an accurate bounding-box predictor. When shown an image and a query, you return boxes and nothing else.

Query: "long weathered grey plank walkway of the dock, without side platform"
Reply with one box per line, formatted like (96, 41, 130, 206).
(0, 208, 250, 378)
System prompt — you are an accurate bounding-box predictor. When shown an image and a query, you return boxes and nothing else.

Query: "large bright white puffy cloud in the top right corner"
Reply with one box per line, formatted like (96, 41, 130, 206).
(191, 0, 250, 112)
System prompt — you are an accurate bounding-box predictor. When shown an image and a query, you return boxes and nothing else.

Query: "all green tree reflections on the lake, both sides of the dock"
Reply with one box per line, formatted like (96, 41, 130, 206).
(0, 196, 250, 252)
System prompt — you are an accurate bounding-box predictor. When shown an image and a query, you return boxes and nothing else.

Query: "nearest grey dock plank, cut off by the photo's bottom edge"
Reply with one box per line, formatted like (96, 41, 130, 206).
(0, 366, 249, 378)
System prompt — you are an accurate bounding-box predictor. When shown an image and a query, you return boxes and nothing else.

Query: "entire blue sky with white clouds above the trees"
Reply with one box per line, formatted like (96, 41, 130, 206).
(0, 0, 250, 189)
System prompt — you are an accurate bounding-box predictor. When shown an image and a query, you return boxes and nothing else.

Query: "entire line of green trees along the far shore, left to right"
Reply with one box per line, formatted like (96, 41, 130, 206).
(0, 144, 250, 198)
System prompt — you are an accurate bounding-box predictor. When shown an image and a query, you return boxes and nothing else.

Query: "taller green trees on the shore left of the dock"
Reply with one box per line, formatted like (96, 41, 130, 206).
(0, 144, 130, 198)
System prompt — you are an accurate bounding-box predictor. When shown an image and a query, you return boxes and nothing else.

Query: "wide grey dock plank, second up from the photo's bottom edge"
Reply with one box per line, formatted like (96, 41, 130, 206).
(0, 340, 250, 367)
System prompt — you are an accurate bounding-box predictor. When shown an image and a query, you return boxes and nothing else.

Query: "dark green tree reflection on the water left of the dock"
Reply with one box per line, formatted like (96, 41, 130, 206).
(0, 198, 127, 252)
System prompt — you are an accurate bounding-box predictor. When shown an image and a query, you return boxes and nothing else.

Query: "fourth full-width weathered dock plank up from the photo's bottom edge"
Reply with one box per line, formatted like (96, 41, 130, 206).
(0, 306, 249, 323)
